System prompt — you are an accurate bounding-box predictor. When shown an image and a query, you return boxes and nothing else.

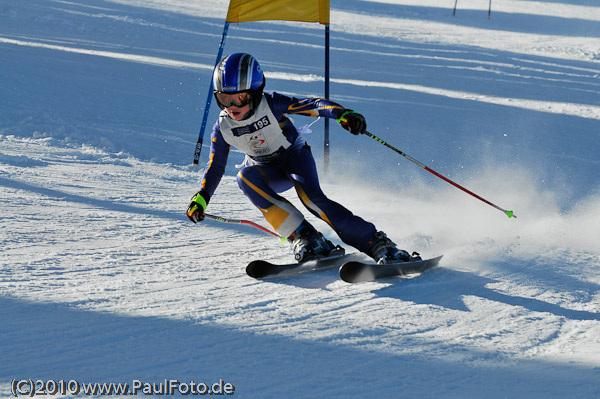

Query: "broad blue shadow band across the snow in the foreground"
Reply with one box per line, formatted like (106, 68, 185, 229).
(0, 296, 600, 399)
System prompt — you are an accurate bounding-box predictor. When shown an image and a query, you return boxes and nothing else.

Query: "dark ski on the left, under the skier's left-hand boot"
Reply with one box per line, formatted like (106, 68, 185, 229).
(246, 252, 362, 279)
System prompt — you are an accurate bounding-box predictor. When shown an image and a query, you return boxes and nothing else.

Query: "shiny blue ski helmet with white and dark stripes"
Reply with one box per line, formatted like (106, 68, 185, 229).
(213, 53, 265, 109)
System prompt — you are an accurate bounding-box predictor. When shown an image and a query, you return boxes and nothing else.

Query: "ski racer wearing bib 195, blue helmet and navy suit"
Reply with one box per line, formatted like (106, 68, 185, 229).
(187, 53, 412, 263)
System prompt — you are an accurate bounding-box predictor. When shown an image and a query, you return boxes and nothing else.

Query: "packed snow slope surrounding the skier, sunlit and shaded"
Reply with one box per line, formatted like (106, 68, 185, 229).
(0, 0, 600, 399)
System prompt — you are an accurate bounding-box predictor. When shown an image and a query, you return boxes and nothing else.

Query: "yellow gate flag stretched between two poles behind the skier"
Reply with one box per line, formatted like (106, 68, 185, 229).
(226, 0, 329, 25)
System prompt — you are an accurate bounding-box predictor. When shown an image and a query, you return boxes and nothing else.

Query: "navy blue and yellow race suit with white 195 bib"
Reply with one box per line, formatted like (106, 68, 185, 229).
(200, 93, 376, 252)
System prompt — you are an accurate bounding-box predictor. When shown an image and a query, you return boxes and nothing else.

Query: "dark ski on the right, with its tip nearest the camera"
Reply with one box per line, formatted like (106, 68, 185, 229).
(340, 255, 443, 283)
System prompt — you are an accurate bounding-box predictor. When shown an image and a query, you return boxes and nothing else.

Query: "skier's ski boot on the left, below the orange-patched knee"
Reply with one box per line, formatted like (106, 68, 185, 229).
(288, 221, 345, 263)
